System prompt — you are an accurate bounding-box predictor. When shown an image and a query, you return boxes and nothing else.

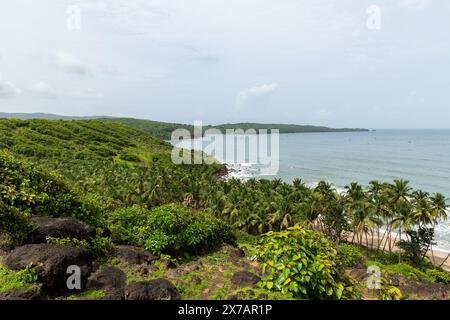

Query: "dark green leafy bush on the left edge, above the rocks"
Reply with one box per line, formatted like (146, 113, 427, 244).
(0, 150, 101, 229)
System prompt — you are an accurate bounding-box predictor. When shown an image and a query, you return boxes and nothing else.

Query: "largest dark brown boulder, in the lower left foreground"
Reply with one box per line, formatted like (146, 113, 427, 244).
(3, 244, 92, 292)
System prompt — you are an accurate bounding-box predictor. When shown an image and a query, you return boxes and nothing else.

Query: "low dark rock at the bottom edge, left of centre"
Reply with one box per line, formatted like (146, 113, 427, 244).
(125, 279, 180, 300)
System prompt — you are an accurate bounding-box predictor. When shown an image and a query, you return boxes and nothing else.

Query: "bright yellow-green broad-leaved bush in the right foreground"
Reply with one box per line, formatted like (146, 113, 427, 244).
(256, 227, 353, 299)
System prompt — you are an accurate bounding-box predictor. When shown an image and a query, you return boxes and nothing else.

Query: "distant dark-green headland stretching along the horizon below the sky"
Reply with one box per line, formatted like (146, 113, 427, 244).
(0, 112, 370, 140)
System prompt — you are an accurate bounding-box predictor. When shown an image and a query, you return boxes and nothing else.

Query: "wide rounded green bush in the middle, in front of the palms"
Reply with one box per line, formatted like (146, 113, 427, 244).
(108, 205, 234, 255)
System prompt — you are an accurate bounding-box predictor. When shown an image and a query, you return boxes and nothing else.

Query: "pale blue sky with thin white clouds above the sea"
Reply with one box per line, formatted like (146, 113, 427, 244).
(0, 0, 450, 128)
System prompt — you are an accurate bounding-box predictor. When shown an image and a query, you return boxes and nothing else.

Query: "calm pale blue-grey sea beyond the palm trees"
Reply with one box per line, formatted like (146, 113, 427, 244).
(174, 130, 450, 250)
